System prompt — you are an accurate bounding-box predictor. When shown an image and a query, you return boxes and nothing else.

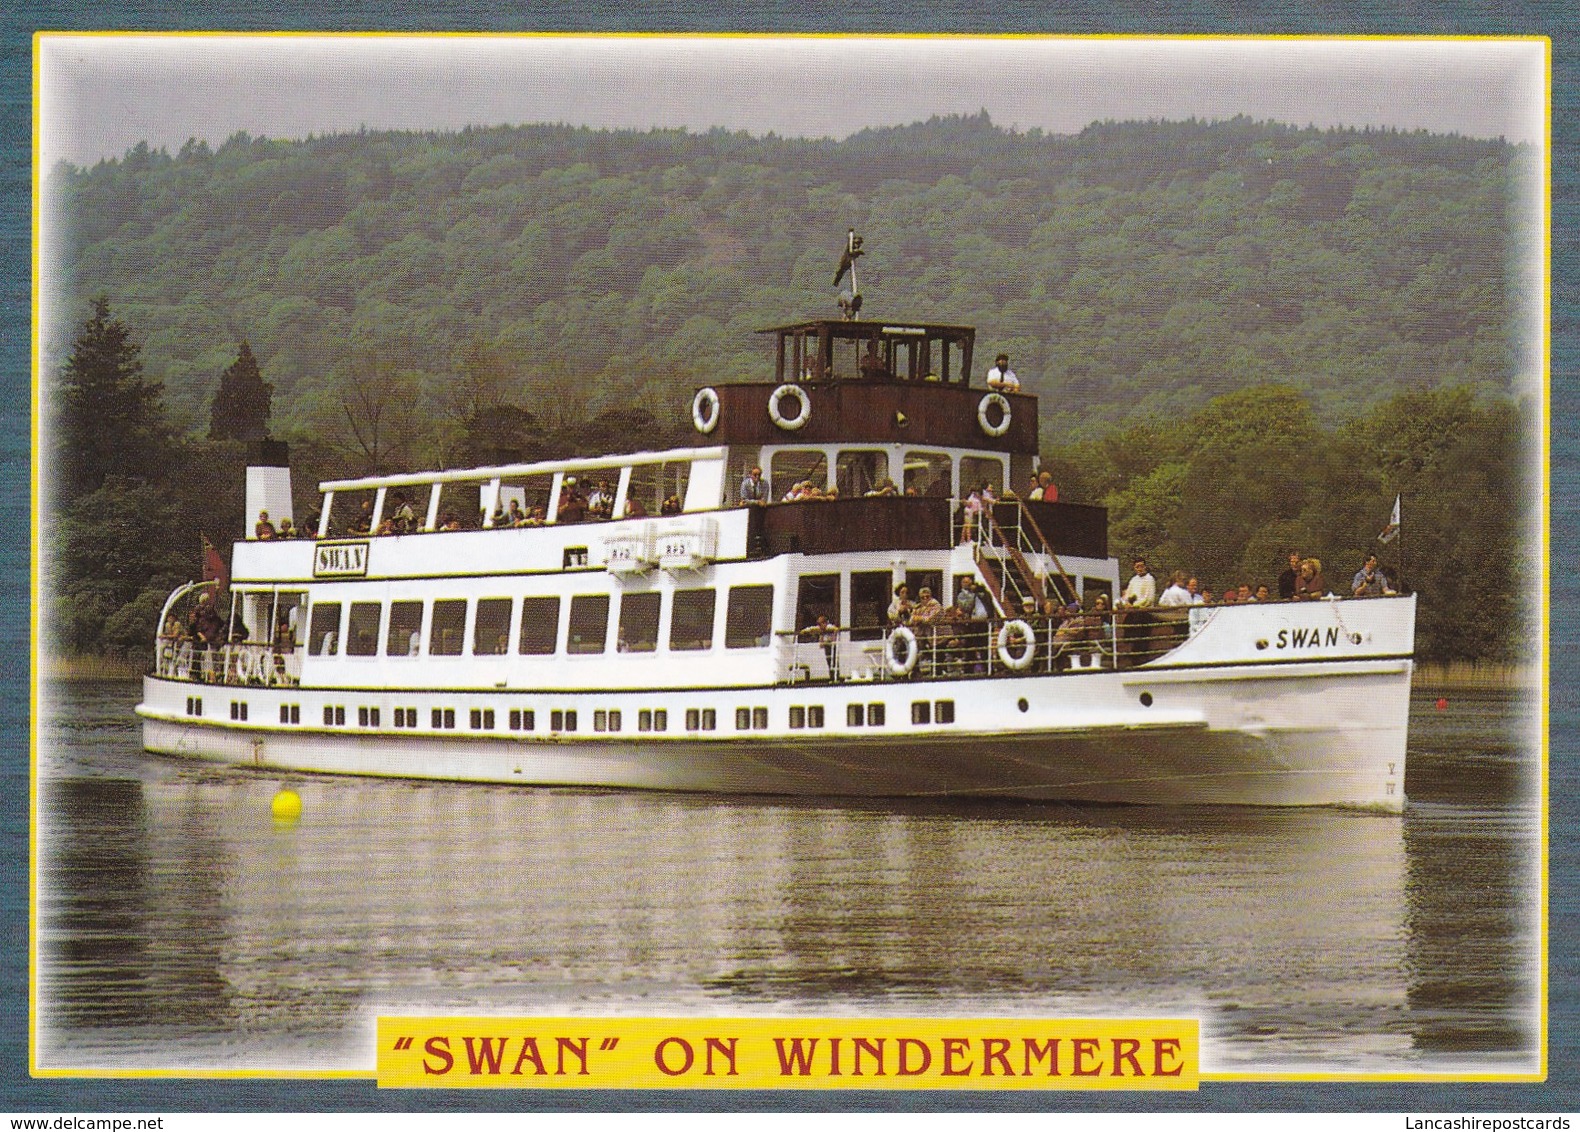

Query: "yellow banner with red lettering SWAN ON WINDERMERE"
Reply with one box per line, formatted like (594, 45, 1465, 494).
(378, 1018, 1201, 1089)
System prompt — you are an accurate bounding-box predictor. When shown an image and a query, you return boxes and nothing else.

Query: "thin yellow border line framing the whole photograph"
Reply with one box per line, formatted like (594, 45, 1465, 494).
(27, 30, 1553, 1085)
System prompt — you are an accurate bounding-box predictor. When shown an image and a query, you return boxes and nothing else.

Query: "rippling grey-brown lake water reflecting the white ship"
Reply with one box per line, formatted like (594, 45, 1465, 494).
(35, 683, 1541, 1074)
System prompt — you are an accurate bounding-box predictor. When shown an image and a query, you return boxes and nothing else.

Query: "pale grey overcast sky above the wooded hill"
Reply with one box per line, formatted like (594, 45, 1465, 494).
(40, 35, 1547, 168)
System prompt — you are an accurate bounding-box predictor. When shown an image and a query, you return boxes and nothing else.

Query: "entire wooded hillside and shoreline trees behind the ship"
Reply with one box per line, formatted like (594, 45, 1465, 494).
(44, 115, 1536, 658)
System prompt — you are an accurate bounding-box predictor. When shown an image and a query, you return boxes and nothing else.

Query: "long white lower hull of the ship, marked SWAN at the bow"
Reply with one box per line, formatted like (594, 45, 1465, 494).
(139, 658, 1411, 811)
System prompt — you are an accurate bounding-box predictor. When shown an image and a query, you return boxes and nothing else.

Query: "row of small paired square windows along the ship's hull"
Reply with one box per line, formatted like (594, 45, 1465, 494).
(202, 696, 954, 732)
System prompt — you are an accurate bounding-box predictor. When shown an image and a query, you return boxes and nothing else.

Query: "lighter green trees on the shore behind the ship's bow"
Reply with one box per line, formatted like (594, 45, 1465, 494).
(1044, 386, 1537, 661)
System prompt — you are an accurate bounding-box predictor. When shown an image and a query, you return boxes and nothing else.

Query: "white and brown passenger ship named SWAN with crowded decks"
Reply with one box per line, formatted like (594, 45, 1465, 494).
(137, 311, 1414, 811)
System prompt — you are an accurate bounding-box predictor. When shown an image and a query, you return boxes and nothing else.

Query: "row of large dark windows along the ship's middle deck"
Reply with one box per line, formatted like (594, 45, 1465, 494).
(308, 585, 774, 656)
